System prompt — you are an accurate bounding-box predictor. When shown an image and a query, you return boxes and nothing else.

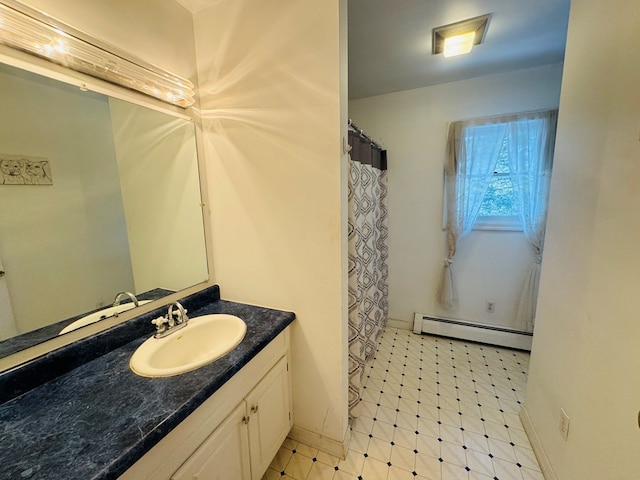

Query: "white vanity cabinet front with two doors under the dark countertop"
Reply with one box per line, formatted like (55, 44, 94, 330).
(120, 328, 292, 480)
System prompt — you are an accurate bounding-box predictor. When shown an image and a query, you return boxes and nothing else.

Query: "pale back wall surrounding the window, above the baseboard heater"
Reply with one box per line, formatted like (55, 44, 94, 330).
(349, 65, 562, 328)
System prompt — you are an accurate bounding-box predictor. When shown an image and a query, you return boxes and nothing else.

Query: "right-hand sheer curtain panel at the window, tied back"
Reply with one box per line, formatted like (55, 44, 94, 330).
(507, 110, 558, 332)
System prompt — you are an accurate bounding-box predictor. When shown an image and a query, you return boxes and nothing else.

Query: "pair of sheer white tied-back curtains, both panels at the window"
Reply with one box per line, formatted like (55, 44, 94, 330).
(437, 110, 557, 331)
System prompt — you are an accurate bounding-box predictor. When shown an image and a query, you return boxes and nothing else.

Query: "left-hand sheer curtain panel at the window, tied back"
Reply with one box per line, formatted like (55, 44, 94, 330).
(437, 121, 507, 309)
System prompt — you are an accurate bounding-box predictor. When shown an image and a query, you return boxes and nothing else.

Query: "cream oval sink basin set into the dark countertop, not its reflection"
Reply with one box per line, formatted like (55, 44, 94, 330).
(129, 314, 247, 377)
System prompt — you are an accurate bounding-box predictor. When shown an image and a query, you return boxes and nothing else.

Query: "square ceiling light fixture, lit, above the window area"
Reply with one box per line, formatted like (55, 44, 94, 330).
(432, 14, 491, 57)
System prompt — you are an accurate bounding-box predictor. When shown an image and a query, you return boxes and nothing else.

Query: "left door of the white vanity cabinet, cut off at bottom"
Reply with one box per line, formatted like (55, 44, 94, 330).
(171, 402, 251, 480)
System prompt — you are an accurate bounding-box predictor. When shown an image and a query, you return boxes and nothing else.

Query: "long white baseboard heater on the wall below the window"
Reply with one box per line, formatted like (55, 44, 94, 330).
(413, 313, 533, 350)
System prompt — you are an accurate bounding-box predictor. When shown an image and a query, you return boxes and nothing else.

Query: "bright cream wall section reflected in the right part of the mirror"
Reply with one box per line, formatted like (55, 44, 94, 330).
(109, 98, 208, 292)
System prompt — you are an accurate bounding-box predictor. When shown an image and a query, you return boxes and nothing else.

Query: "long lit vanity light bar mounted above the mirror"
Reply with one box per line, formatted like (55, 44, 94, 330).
(0, 0, 194, 108)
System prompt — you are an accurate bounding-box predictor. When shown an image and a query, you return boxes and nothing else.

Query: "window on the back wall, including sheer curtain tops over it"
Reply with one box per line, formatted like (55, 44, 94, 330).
(445, 112, 555, 235)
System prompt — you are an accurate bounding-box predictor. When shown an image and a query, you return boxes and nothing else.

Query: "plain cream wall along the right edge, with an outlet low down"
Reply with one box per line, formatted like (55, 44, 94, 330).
(526, 0, 640, 480)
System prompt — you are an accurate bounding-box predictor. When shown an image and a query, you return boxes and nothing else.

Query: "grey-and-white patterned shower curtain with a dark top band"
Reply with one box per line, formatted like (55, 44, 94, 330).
(348, 127, 389, 418)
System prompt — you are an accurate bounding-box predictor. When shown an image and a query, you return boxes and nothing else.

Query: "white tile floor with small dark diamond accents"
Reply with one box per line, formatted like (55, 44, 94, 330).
(263, 328, 544, 480)
